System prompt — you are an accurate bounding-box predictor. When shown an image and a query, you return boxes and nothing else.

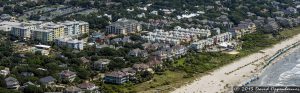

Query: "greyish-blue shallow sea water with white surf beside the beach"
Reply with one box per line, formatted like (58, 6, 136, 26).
(249, 47, 300, 86)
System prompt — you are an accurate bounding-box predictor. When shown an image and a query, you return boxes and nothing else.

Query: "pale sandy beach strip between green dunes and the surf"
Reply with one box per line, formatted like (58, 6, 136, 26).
(172, 35, 300, 93)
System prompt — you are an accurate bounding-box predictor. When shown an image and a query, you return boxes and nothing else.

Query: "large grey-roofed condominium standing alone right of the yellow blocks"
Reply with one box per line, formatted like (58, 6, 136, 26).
(106, 18, 142, 35)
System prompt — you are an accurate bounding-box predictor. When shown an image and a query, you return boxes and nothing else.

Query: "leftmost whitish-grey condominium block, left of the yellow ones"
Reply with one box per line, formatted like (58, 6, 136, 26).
(10, 23, 36, 40)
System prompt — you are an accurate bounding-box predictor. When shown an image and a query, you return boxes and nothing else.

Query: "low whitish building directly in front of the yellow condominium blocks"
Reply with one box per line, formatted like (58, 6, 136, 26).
(55, 38, 84, 50)
